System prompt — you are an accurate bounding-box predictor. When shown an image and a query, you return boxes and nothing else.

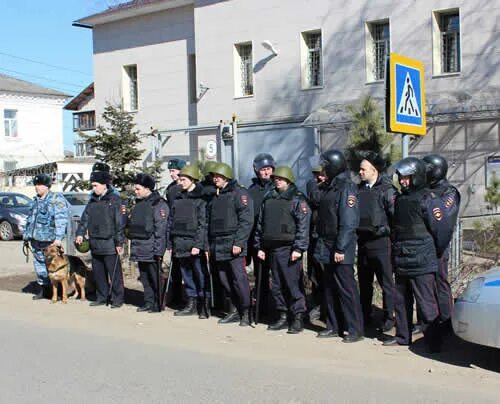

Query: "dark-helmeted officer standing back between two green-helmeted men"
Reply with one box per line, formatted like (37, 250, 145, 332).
(248, 153, 276, 315)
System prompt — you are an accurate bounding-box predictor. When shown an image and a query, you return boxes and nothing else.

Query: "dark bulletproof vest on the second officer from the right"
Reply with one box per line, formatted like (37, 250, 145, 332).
(394, 189, 431, 241)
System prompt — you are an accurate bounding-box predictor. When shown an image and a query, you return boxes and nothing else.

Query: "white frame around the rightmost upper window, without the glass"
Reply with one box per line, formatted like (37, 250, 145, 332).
(432, 8, 462, 76)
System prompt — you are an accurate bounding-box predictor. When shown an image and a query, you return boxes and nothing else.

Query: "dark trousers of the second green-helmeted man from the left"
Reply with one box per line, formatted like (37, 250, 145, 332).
(216, 257, 250, 311)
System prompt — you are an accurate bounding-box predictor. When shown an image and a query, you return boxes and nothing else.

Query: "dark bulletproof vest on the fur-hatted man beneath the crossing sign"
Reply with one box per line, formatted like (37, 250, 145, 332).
(358, 186, 387, 234)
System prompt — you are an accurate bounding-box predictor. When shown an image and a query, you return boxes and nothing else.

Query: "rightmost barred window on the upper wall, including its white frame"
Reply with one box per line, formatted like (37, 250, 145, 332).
(433, 10, 461, 74)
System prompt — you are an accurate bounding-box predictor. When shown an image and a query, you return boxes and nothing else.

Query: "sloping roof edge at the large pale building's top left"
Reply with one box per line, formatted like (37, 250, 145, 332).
(73, 0, 194, 28)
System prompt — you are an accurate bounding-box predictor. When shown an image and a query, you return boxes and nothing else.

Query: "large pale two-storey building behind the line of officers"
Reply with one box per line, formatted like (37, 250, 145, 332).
(75, 0, 500, 214)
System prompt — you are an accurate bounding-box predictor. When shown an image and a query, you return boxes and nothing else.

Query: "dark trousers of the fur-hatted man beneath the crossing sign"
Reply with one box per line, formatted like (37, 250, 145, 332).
(358, 246, 394, 322)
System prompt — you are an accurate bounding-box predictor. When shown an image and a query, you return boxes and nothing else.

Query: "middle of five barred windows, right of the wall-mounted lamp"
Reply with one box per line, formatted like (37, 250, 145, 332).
(301, 31, 323, 88)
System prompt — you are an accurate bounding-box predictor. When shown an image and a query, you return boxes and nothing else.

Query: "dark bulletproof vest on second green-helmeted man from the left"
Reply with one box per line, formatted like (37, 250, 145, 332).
(209, 192, 238, 236)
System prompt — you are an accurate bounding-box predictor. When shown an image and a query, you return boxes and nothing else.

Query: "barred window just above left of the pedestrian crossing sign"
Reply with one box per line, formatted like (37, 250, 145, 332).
(366, 20, 391, 82)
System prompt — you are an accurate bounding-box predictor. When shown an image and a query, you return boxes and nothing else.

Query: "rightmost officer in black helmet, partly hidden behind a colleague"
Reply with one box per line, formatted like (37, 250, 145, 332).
(423, 154, 460, 332)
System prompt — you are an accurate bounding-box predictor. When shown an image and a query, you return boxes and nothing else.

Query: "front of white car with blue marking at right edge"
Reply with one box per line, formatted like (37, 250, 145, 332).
(452, 267, 500, 348)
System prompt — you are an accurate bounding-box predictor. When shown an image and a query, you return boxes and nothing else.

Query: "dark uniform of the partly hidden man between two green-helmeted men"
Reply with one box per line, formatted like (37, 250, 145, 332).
(248, 177, 274, 315)
